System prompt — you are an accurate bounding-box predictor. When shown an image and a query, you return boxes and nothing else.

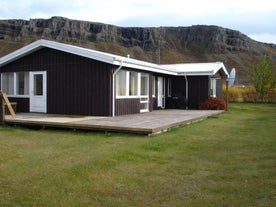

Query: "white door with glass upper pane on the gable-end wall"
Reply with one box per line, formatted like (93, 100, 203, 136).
(30, 71, 47, 113)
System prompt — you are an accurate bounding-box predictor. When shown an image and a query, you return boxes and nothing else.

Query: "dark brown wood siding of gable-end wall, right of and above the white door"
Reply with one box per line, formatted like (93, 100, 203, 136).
(1, 48, 114, 116)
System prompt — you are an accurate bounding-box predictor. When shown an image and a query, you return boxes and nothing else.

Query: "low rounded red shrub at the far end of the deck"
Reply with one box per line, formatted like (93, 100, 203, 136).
(198, 97, 226, 110)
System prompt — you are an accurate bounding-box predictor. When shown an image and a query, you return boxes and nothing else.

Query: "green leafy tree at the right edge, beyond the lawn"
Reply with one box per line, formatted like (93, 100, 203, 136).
(252, 55, 276, 101)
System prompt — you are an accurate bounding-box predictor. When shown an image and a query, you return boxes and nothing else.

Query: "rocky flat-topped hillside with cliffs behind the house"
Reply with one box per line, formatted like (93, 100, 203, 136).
(0, 17, 276, 83)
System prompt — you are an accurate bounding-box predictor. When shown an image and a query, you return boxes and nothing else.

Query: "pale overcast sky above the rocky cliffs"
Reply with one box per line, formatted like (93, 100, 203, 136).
(0, 0, 276, 44)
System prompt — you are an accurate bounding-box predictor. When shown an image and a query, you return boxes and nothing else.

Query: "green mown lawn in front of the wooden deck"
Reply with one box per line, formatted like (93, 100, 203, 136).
(0, 103, 276, 207)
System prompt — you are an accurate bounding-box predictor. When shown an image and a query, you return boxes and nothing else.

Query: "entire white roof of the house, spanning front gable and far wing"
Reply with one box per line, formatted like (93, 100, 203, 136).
(0, 39, 228, 76)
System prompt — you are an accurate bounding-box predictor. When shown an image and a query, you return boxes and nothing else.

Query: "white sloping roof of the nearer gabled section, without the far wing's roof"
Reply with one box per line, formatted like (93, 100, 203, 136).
(0, 39, 177, 75)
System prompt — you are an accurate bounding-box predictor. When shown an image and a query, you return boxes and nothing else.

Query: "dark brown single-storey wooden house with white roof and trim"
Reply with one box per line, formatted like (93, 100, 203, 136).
(0, 39, 228, 116)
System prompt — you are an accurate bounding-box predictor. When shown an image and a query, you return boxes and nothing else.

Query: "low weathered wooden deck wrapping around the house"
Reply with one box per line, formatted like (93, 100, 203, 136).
(4, 110, 223, 135)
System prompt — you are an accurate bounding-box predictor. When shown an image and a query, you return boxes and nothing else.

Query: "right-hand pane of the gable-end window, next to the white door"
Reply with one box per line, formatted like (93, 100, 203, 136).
(16, 72, 29, 95)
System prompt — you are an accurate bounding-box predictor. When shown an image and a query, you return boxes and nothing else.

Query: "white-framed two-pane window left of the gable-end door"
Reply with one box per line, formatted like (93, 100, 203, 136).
(1, 72, 29, 96)
